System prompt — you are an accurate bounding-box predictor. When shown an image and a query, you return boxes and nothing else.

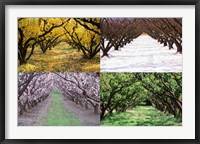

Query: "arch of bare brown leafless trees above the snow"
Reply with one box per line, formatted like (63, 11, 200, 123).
(100, 18, 182, 57)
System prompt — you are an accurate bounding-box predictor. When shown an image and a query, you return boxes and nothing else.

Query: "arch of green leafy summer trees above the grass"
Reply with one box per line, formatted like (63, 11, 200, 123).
(100, 73, 182, 120)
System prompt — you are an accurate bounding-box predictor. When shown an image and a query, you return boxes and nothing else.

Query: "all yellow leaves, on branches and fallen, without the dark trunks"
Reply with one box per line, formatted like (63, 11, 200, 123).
(18, 18, 100, 72)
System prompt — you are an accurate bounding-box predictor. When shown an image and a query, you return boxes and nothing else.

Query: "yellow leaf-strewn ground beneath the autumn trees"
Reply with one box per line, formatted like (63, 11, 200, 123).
(18, 43, 100, 72)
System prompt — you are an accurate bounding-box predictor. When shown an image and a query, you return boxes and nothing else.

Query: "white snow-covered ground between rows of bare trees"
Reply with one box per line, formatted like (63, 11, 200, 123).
(101, 35, 182, 72)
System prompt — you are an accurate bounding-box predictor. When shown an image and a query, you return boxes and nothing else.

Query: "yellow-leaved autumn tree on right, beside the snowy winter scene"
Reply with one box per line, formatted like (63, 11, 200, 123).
(64, 18, 100, 59)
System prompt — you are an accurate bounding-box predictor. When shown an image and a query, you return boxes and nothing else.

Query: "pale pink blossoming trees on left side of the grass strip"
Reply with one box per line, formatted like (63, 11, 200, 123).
(18, 73, 51, 115)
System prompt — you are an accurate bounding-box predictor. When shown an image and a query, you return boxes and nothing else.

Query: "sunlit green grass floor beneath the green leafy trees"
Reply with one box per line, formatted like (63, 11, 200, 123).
(101, 106, 182, 126)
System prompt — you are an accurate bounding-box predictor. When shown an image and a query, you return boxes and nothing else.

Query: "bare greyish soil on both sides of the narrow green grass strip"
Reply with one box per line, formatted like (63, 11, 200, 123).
(18, 96, 100, 126)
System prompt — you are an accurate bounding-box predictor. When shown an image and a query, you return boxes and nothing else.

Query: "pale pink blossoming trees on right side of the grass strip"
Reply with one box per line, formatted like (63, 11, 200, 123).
(55, 73, 100, 114)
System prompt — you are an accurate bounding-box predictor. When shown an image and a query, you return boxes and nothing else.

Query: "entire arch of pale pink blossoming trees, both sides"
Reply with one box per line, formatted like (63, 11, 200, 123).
(18, 72, 100, 115)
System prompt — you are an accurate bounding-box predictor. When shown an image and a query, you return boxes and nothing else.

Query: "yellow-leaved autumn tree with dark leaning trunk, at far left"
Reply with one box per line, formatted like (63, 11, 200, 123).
(18, 18, 67, 65)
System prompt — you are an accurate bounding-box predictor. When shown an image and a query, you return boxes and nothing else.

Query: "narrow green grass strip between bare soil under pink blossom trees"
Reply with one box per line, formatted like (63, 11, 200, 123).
(39, 92, 80, 126)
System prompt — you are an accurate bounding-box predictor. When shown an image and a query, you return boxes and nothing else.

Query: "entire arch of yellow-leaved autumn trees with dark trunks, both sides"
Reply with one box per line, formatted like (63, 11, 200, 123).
(18, 18, 100, 65)
